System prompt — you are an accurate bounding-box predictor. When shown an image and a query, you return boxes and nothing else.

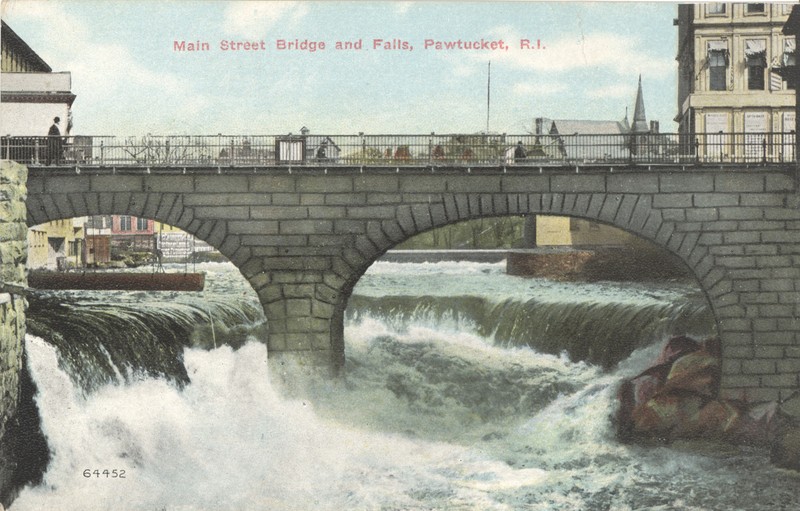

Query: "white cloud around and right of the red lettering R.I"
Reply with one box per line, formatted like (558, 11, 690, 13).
(468, 26, 675, 77)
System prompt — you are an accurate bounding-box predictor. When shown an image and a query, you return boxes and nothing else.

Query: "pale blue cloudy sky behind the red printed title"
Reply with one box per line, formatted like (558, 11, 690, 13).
(2, 0, 677, 135)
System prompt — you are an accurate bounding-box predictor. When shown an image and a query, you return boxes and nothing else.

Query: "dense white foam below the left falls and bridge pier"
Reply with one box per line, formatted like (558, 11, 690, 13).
(13, 337, 494, 510)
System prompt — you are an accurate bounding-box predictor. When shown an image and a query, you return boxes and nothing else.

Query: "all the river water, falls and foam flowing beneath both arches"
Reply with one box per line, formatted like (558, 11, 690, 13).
(11, 262, 800, 511)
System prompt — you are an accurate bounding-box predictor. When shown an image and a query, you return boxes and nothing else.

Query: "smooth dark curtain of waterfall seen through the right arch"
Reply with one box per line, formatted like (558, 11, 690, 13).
(347, 295, 714, 368)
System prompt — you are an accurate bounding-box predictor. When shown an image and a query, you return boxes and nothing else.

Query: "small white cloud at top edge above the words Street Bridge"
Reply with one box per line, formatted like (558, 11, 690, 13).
(222, 1, 308, 37)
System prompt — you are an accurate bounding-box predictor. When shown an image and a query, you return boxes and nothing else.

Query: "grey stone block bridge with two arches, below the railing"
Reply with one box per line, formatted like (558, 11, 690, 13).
(21, 165, 800, 400)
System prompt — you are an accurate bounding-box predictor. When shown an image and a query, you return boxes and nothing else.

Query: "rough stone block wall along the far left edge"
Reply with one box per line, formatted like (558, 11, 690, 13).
(0, 160, 28, 505)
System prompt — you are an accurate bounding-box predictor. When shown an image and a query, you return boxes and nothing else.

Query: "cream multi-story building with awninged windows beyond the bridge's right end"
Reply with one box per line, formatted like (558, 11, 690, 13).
(675, 2, 795, 161)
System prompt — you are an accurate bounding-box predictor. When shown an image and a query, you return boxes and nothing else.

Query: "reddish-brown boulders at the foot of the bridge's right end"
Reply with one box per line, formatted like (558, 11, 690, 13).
(615, 337, 800, 470)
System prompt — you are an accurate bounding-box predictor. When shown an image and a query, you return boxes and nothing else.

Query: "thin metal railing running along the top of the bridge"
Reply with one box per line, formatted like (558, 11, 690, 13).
(0, 133, 796, 167)
